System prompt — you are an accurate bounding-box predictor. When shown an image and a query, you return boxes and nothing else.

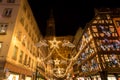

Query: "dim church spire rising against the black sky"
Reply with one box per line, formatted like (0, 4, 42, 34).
(46, 9, 55, 37)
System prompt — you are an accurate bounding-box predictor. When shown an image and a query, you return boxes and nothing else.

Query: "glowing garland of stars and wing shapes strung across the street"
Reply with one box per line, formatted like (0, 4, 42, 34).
(36, 37, 83, 77)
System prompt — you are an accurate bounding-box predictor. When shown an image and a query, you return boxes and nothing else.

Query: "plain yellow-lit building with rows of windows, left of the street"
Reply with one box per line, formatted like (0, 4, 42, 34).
(0, 0, 42, 80)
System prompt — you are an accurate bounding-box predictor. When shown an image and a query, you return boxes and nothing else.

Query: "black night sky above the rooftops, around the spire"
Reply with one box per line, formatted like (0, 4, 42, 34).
(28, 0, 120, 36)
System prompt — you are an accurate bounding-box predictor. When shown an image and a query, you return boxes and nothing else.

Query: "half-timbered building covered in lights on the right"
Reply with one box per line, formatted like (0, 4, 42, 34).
(76, 8, 120, 80)
